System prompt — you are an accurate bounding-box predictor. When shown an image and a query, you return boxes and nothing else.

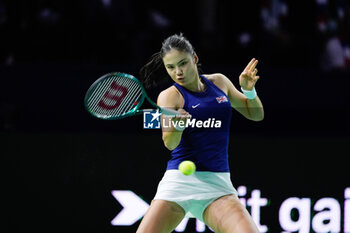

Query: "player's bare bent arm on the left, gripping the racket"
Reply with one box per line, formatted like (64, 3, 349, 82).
(157, 86, 190, 150)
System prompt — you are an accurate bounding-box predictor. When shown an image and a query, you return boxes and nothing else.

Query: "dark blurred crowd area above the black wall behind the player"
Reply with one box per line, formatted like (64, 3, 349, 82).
(0, 0, 350, 70)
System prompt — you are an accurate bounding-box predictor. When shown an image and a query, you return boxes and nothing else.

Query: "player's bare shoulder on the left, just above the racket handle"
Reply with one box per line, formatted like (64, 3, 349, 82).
(157, 86, 184, 109)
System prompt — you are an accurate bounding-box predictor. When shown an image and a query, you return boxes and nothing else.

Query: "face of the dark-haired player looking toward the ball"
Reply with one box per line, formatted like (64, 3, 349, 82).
(163, 49, 198, 86)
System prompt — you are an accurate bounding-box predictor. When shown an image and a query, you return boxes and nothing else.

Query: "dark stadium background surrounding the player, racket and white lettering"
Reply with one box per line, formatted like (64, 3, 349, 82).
(0, 0, 350, 233)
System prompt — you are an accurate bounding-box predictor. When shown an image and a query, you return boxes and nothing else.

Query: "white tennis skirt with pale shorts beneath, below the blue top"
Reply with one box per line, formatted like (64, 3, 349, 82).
(154, 170, 237, 221)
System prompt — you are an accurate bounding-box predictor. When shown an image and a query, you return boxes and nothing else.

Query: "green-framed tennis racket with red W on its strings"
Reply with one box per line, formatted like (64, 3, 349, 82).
(84, 72, 181, 120)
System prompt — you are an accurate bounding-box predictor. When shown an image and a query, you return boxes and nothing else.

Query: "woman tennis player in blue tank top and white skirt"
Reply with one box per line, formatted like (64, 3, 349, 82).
(137, 34, 264, 233)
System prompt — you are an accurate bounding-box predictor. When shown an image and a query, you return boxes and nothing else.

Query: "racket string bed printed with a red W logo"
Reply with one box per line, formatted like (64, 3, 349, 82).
(87, 76, 142, 118)
